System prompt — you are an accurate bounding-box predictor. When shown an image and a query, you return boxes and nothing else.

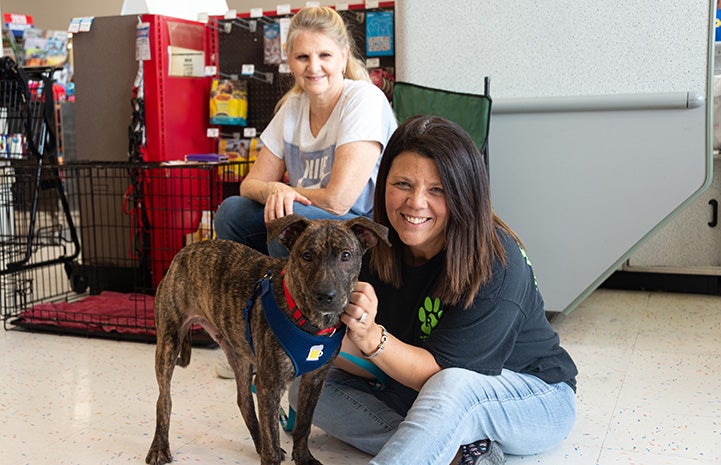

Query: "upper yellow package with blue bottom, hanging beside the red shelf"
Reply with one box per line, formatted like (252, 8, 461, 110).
(210, 79, 248, 126)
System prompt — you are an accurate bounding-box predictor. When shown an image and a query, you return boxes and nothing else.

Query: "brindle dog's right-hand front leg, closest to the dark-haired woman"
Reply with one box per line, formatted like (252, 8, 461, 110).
(293, 362, 331, 465)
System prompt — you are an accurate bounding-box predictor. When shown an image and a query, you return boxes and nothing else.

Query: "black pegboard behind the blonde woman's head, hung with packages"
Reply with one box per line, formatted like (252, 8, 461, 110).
(212, 7, 395, 134)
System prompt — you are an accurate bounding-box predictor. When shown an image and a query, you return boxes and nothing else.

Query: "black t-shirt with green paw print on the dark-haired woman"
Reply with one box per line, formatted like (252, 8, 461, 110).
(360, 228, 578, 414)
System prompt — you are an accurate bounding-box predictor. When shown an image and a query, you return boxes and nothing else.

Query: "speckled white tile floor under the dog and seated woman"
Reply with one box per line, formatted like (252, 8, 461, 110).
(0, 289, 721, 465)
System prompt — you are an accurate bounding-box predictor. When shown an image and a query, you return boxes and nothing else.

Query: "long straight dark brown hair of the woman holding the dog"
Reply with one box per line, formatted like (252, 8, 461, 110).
(371, 115, 520, 308)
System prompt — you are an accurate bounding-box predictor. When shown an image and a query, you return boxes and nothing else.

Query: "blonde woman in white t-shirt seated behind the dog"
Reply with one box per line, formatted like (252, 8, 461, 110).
(215, 7, 397, 255)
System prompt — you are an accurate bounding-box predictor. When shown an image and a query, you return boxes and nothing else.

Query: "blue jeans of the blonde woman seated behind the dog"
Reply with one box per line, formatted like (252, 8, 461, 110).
(214, 195, 358, 257)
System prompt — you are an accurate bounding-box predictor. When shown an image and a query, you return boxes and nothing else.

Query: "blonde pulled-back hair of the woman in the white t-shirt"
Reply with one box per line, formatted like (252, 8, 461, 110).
(275, 6, 371, 111)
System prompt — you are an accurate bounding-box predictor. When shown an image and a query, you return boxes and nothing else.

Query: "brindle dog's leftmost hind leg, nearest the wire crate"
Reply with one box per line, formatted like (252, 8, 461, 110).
(145, 324, 180, 465)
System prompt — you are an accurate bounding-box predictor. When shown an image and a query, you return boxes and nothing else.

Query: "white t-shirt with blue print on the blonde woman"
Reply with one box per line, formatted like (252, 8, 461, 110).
(260, 79, 397, 216)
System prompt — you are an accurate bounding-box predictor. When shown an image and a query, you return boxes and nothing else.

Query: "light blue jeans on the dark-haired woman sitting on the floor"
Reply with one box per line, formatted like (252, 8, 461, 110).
(289, 368, 576, 465)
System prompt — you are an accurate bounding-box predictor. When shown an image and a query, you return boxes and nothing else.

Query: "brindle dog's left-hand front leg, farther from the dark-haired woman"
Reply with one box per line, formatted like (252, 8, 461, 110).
(255, 366, 285, 465)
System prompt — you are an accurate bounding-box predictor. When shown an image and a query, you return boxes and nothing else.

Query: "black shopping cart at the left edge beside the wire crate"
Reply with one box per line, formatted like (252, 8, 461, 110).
(0, 57, 80, 276)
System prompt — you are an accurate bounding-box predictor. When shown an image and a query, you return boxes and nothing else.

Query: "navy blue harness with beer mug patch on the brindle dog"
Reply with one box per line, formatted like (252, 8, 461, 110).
(243, 271, 345, 376)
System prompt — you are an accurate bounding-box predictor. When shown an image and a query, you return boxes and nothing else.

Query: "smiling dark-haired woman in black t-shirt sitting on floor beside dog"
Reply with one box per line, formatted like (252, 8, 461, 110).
(291, 115, 577, 465)
